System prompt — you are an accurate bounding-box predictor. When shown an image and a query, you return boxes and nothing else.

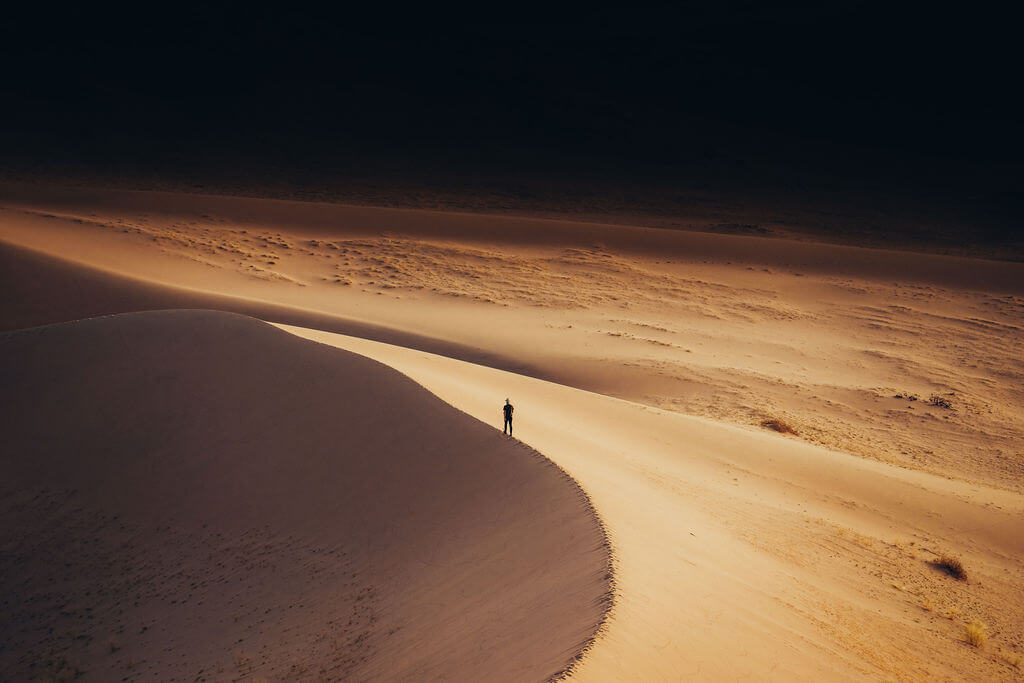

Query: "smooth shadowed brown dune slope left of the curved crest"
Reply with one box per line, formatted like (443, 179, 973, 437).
(0, 310, 609, 680)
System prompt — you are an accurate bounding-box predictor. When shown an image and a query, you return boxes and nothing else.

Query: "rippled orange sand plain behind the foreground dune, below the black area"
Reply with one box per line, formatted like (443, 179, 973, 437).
(0, 186, 1024, 490)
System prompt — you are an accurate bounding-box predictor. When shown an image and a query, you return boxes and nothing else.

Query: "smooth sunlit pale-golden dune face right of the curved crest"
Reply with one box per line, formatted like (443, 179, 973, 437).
(280, 326, 1024, 680)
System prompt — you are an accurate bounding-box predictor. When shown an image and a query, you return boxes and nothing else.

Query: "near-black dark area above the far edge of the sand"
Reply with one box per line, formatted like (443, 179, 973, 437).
(0, 2, 1024, 257)
